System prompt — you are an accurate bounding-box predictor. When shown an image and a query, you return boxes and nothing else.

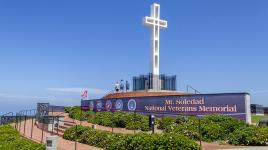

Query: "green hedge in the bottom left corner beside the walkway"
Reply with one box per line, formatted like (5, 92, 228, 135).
(0, 125, 45, 150)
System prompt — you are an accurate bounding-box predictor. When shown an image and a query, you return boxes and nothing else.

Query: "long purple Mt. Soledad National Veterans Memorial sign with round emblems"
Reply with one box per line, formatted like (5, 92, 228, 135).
(81, 93, 251, 123)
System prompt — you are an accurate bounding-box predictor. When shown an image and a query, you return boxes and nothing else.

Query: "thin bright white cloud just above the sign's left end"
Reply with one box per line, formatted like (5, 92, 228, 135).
(47, 88, 108, 95)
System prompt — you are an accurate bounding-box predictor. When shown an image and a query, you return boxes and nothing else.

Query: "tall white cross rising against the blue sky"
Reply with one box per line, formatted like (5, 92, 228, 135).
(143, 3, 167, 75)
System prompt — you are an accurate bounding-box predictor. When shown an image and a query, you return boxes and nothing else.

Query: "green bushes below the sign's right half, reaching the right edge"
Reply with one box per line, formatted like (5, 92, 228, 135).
(160, 115, 268, 146)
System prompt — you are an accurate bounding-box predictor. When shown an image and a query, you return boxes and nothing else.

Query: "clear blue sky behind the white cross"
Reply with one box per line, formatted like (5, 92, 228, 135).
(0, 0, 268, 113)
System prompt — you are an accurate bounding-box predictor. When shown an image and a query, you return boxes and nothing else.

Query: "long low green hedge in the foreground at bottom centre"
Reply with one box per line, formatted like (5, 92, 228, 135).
(63, 126, 200, 150)
